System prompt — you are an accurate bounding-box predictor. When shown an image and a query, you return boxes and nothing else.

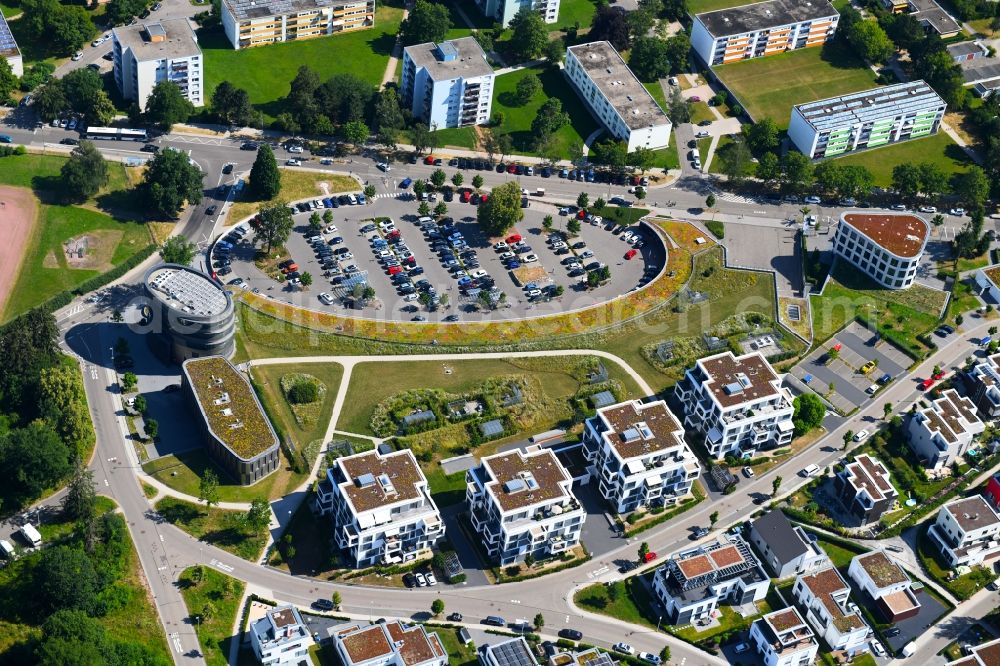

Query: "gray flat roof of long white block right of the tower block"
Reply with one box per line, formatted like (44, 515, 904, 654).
(569, 42, 670, 129)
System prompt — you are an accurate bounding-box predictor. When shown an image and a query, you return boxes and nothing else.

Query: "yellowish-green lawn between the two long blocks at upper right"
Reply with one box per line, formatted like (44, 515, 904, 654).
(714, 43, 876, 129)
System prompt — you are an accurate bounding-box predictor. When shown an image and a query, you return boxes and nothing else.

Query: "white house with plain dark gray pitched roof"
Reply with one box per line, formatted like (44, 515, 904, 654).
(749, 509, 830, 578)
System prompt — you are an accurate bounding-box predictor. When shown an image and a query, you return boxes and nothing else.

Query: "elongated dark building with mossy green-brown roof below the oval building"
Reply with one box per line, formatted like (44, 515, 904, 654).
(181, 356, 280, 486)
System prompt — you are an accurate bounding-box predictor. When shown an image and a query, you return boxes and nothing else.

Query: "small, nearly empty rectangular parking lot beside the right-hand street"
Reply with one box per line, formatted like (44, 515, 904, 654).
(792, 322, 910, 414)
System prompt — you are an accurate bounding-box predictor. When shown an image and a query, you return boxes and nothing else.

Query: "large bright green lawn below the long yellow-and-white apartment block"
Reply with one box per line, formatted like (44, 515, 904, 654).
(198, 2, 403, 120)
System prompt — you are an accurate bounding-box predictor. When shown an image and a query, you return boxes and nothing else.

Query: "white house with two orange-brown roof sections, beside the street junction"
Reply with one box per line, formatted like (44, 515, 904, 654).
(653, 535, 771, 624)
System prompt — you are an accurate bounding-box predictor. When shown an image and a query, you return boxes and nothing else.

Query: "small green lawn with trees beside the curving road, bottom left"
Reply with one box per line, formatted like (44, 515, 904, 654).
(177, 566, 246, 666)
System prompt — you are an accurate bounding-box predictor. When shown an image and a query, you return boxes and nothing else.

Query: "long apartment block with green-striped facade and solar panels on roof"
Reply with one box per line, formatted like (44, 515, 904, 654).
(788, 81, 947, 159)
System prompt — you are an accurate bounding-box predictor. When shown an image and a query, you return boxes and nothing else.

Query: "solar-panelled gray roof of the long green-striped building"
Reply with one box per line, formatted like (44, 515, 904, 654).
(795, 81, 945, 131)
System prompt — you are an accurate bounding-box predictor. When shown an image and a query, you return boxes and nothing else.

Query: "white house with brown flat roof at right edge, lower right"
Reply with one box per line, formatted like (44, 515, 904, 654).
(927, 495, 1000, 569)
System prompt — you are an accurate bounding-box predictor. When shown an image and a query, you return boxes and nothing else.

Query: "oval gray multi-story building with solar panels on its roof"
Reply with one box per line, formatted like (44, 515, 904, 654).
(144, 264, 236, 363)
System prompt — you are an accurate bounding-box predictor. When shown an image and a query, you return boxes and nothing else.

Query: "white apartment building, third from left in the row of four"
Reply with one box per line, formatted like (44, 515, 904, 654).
(583, 400, 701, 513)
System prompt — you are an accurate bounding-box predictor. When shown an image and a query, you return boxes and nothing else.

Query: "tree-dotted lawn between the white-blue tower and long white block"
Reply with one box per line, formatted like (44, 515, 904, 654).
(493, 67, 597, 159)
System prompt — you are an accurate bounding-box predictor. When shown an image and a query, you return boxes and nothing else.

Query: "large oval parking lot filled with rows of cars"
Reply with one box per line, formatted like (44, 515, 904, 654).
(223, 193, 666, 321)
